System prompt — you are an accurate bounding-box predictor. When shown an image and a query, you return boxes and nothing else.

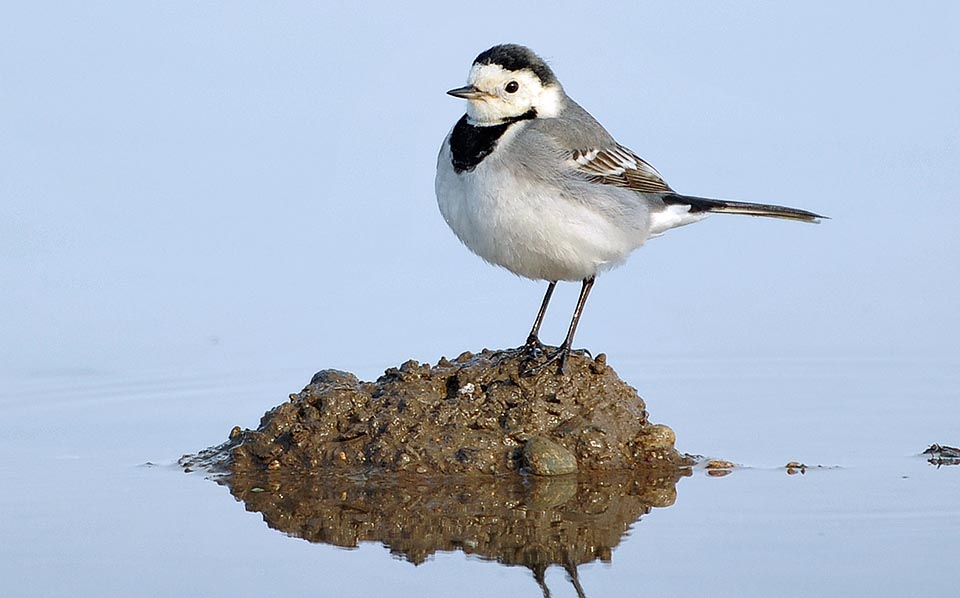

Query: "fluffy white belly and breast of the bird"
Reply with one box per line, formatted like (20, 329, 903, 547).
(436, 144, 650, 281)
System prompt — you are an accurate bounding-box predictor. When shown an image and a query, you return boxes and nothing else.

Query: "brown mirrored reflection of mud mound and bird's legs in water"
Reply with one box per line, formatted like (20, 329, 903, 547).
(223, 469, 689, 596)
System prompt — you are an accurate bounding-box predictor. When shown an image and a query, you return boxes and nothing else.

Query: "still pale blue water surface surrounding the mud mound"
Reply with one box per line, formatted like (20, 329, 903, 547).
(0, 356, 960, 596)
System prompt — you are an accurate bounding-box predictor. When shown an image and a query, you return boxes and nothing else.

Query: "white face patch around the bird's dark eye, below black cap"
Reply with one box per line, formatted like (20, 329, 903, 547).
(467, 64, 562, 124)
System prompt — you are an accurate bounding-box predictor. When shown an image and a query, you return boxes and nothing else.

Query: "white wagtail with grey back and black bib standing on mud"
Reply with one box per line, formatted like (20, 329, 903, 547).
(436, 44, 821, 372)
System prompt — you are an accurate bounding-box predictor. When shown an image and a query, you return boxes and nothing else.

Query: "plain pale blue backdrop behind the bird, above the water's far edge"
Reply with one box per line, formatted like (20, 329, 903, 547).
(0, 1, 960, 375)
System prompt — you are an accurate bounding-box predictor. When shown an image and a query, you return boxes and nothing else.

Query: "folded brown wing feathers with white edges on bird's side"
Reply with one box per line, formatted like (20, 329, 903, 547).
(569, 143, 673, 193)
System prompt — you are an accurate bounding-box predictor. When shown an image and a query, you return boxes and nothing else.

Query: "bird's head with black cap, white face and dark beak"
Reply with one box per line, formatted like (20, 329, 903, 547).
(447, 44, 564, 126)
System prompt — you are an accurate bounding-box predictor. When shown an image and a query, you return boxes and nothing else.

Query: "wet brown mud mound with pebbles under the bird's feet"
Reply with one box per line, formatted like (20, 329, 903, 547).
(186, 351, 685, 475)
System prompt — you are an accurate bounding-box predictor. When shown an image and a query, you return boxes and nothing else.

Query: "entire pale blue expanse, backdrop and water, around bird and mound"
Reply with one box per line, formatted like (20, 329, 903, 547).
(0, 0, 960, 596)
